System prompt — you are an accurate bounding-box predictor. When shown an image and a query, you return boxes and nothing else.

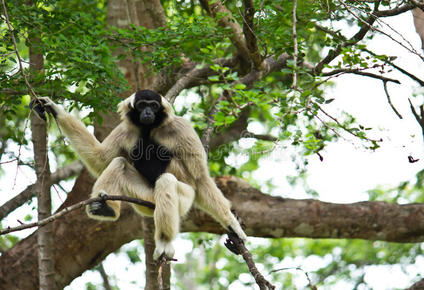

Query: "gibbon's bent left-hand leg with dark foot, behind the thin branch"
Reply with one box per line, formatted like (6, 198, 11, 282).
(86, 157, 154, 221)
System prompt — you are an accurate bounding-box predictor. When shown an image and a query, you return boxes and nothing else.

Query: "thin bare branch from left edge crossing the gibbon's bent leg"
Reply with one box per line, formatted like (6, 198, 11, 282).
(0, 195, 155, 236)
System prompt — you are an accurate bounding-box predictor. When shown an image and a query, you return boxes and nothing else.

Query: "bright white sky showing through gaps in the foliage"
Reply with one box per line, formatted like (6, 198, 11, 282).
(0, 7, 424, 290)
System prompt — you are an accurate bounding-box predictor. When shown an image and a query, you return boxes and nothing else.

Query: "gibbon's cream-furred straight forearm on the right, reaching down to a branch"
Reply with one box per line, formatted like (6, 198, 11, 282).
(195, 177, 247, 241)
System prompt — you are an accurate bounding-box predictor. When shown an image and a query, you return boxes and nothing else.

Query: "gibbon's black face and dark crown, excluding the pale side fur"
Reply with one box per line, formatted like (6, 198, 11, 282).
(128, 90, 166, 128)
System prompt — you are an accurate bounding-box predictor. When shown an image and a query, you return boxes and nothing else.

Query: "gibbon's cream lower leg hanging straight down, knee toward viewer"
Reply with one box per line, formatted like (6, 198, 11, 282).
(153, 173, 194, 260)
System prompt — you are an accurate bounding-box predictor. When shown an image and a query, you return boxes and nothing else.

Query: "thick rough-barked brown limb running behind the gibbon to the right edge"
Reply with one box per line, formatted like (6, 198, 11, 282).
(0, 173, 424, 289)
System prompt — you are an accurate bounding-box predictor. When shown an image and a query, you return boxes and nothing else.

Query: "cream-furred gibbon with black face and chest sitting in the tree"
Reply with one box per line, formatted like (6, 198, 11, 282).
(30, 90, 247, 259)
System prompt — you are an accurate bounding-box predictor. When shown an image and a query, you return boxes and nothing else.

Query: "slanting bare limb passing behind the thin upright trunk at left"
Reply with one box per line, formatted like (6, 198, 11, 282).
(0, 161, 83, 220)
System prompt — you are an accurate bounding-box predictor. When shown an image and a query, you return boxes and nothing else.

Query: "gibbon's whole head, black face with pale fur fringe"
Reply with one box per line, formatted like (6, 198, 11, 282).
(118, 90, 173, 128)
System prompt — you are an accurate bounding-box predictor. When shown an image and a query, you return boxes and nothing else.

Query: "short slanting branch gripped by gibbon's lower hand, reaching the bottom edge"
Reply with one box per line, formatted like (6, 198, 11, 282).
(224, 232, 275, 290)
